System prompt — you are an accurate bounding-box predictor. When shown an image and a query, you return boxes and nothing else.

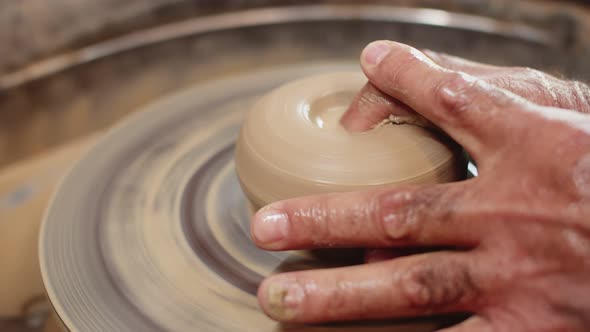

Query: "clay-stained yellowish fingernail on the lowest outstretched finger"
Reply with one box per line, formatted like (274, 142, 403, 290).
(266, 280, 305, 321)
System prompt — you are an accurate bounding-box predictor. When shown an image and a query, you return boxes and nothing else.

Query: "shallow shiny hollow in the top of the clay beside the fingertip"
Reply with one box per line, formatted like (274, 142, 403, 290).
(309, 91, 355, 128)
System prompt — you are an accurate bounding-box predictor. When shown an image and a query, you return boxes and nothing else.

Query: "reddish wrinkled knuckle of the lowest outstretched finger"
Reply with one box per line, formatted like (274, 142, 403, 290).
(400, 261, 478, 312)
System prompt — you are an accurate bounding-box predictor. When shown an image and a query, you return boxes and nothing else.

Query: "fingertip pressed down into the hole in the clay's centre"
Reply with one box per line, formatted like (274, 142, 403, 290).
(340, 82, 428, 132)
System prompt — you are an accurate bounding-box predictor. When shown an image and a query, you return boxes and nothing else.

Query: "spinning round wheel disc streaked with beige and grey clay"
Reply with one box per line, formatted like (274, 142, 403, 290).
(40, 63, 448, 331)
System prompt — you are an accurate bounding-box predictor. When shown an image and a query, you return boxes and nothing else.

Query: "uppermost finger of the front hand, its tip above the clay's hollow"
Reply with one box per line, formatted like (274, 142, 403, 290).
(361, 41, 527, 161)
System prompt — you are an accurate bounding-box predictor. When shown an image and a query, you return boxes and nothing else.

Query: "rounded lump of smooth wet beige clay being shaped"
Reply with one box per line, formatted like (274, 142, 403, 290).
(235, 72, 466, 209)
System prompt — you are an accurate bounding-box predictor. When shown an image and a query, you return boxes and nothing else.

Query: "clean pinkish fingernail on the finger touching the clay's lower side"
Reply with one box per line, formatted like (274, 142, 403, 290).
(252, 209, 289, 244)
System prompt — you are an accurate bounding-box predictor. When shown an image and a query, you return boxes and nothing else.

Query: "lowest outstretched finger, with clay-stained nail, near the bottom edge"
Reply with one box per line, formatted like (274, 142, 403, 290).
(258, 252, 481, 322)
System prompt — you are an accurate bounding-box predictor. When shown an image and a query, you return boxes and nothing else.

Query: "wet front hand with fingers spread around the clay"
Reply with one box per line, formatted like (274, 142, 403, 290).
(252, 42, 590, 332)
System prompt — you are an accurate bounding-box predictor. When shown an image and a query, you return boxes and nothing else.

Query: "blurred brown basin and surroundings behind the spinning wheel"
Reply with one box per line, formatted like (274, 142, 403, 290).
(0, 0, 590, 332)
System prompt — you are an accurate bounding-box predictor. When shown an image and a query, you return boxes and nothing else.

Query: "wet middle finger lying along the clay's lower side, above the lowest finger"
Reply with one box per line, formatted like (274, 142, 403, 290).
(251, 180, 485, 250)
